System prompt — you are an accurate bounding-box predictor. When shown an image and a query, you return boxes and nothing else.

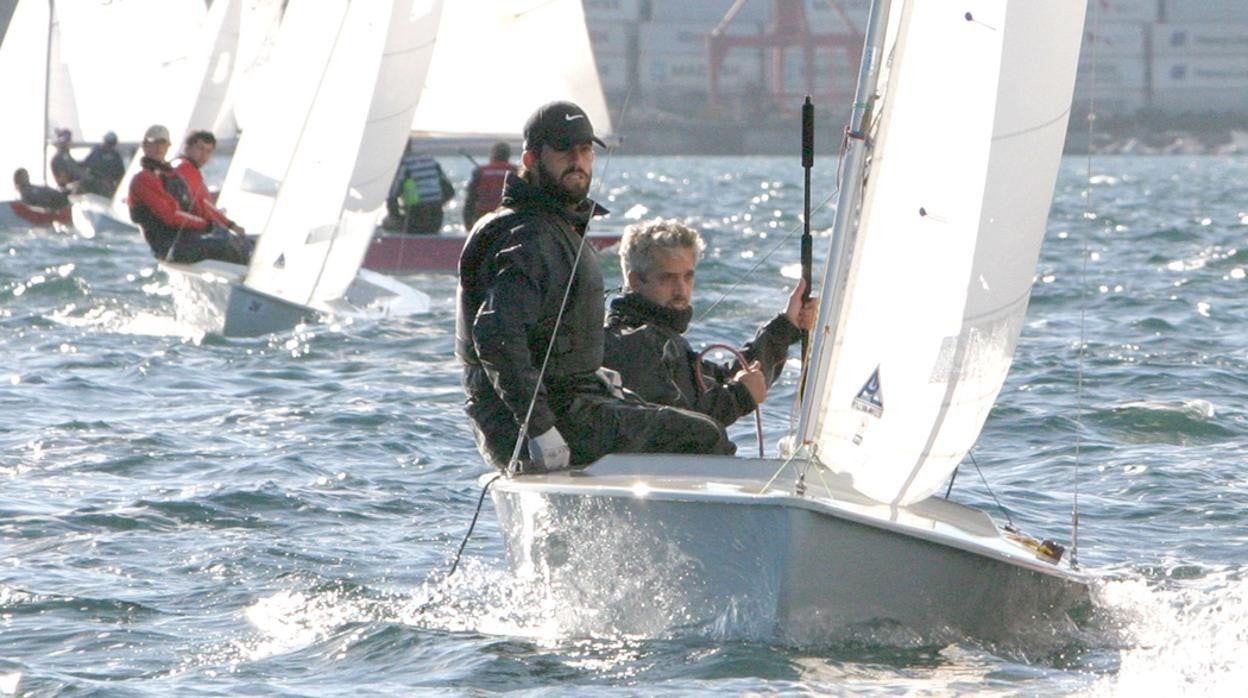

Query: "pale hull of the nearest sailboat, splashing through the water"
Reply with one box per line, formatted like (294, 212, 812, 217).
(490, 456, 1088, 642)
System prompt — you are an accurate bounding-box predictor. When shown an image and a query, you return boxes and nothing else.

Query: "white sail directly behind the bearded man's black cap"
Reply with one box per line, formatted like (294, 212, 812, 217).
(412, 0, 612, 137)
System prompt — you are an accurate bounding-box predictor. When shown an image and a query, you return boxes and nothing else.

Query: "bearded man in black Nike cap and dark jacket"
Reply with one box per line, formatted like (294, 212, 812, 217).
(456, 101, 735, 472)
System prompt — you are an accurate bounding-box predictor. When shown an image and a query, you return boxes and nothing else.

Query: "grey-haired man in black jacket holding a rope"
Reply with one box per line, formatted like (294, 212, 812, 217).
(603, 219, 817, 425)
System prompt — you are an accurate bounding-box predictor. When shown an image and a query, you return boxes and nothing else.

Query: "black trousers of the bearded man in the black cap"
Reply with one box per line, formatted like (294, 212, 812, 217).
(464, 368, 736, 469)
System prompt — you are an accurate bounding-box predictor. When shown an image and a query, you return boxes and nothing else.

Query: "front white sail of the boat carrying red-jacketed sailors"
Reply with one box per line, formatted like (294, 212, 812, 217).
(243, 0, 441, 305)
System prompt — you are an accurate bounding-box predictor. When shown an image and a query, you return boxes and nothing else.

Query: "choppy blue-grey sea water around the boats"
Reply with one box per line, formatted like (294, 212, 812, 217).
(0, 156, 1248, 696)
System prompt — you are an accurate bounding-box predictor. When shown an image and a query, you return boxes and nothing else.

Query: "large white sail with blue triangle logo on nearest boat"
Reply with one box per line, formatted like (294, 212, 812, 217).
(799, 0, 1085, 504)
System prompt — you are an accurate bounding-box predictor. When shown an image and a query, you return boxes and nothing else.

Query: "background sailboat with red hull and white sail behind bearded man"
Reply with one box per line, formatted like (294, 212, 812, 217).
(364, 0, 619, 273)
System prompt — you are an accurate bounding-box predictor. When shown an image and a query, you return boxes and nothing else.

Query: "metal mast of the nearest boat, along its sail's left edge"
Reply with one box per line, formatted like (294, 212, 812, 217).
(794, 0, 892, 455)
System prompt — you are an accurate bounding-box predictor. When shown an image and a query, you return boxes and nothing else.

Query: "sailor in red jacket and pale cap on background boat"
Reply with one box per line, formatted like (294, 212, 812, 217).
(130, 125, 252, 265)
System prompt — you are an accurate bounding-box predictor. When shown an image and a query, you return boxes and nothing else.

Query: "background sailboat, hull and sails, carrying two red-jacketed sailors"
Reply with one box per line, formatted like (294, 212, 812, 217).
(162, 0, 442, 336)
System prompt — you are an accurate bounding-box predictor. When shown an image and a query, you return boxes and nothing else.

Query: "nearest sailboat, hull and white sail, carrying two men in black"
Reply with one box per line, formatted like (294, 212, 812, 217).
(483, 0, 1088, 641)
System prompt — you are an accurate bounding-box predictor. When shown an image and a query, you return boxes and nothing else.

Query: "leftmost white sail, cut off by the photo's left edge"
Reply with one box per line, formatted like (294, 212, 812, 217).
(0, 0, 51, 200)
